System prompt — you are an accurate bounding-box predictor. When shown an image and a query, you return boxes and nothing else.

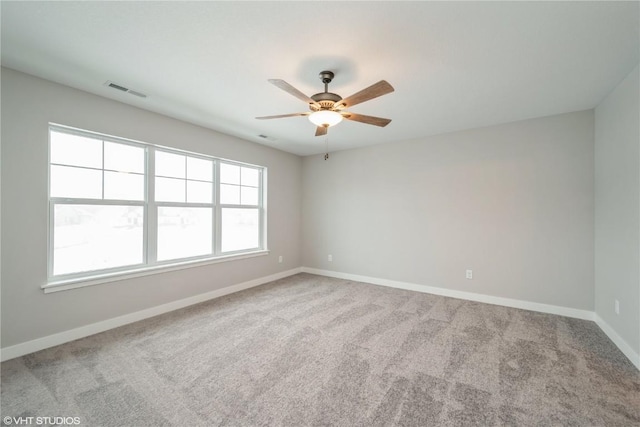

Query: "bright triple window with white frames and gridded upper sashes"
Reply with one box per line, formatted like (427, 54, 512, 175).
(49, 125, 265, 281)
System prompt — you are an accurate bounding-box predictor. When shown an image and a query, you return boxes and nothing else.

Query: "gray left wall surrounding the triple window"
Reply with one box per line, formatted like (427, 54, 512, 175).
(1, 68, 302, 348)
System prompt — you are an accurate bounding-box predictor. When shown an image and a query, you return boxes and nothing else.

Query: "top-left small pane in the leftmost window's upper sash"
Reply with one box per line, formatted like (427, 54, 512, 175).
(50, 131, 102, 168)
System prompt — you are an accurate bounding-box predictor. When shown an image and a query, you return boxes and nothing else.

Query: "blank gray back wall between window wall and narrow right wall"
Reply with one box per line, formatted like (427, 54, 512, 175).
(303, 110, 594, 310)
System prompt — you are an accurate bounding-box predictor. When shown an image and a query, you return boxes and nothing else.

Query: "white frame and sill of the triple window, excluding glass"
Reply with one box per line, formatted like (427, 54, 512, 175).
(42, 123, 269, 292)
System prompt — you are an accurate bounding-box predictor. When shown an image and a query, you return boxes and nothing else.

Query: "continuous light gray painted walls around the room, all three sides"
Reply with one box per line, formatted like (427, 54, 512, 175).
(5, 62, 640, 358)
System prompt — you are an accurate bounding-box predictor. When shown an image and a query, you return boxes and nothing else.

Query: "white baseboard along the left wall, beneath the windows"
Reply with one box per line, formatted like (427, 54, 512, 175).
(0, 268, 302, 362)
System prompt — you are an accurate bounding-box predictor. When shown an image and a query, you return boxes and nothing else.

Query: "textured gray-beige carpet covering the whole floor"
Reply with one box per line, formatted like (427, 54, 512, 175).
(1, 274, 640, 426)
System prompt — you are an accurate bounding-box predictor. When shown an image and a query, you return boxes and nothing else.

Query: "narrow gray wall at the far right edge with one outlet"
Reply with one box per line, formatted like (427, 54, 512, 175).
(595, 63, 640, 354)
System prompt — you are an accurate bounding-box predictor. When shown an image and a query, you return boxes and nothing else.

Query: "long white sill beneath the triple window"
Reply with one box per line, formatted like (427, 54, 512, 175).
(41, 249, 269, 294)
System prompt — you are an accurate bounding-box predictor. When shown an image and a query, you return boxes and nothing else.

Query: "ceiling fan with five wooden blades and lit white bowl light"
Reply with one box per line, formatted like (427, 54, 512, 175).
(256, 71, 394, 136)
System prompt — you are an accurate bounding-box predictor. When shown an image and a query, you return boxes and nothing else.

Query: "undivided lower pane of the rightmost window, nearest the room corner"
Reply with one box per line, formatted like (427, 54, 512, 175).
(222, 208, 260, 252)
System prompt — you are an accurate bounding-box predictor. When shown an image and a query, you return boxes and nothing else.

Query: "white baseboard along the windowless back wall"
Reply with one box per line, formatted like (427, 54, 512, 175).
(302, 267, 595, 320)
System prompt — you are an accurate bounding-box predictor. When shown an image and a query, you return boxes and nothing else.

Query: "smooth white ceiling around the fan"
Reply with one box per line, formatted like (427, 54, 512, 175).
(1, 1, 640, 155)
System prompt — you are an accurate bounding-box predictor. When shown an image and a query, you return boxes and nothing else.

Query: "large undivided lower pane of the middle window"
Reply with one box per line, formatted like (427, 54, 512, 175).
(158, 207, 213, 261)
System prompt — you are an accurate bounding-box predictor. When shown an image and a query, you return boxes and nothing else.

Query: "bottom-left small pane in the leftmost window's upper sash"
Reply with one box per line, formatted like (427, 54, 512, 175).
(51, 165, 102, 199)
